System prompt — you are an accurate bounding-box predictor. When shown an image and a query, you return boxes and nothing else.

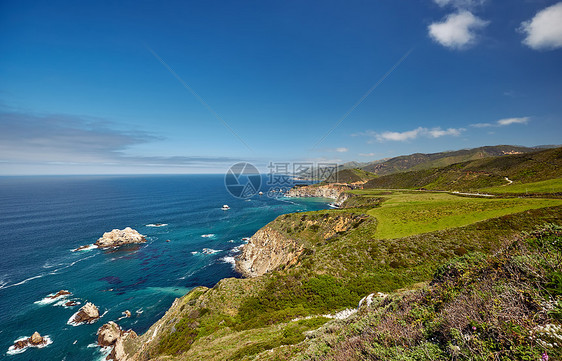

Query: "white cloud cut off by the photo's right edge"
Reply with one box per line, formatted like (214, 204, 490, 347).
(519, 2, 562, 50)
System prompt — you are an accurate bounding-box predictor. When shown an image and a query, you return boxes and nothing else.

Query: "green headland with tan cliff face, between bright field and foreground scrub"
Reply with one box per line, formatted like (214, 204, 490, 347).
(115, 204, 562, 361)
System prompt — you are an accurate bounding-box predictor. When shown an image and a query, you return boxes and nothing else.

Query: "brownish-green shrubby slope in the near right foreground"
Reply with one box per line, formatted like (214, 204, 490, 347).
(280, 227, 562, 361)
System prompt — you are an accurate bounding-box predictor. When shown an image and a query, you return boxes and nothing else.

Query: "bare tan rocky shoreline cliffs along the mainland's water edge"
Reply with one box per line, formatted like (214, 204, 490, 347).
(102, 184, 352, 361)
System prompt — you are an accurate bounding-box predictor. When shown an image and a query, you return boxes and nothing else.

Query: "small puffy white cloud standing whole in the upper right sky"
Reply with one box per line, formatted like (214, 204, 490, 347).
(428, 10, 489, 49)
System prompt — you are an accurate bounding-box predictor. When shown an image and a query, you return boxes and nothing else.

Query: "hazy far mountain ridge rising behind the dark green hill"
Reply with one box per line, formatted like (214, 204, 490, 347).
(361, 145, 545, 175)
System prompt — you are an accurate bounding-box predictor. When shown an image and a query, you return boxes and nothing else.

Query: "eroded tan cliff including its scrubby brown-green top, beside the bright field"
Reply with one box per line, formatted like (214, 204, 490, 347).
(236, 212, 368, 277)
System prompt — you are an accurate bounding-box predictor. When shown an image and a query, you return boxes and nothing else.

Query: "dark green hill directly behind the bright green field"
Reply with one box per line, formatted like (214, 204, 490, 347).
(364, 148, 562, 191)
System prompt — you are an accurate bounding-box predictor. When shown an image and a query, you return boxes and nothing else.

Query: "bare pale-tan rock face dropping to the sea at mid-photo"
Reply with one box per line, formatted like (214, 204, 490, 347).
(235, 226, 304, 277)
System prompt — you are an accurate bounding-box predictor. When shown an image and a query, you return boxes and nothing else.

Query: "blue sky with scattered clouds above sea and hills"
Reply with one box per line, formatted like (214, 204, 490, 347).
(0, 0, 562, 175)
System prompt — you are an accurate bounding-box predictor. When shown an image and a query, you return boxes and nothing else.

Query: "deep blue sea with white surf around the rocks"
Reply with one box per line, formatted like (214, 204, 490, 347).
(0, 175, 328, 361)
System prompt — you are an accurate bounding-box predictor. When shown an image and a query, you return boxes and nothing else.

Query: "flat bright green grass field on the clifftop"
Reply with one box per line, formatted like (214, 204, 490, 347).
(354, 191, 562, 239)
